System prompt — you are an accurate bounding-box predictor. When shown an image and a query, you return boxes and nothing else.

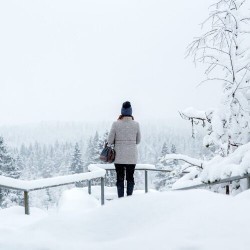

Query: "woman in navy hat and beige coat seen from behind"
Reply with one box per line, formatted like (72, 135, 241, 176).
(108, 102, 141, 198)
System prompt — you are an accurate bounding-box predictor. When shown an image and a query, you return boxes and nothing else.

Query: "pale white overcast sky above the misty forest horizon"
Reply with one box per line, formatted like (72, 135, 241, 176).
(0, 0, 219, 124)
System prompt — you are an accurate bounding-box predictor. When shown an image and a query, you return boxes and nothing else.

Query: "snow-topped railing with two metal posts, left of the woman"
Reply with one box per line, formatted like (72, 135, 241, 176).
(0, 165, 106, 214)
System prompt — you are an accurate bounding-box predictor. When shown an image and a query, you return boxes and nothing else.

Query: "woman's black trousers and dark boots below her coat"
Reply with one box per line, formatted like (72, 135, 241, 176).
(115, 164, 135, 198)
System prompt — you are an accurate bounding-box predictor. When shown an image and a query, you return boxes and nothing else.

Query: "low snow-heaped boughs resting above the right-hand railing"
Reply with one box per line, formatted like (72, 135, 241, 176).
(170, 143, 250, 194)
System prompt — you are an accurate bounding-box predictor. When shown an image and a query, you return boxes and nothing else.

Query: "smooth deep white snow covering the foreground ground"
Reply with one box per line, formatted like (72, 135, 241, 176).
(0, 189, 250, 250)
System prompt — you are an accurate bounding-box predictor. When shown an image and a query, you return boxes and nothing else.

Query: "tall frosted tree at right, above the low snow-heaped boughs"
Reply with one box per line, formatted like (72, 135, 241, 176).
(181, 0, 250, 156)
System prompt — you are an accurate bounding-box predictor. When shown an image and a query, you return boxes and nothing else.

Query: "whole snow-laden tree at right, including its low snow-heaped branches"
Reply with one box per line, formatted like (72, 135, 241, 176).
(169, 0, 250, 192)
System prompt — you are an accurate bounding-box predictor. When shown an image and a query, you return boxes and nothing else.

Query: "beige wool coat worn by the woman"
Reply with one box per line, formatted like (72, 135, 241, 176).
(108, 117, 141, 164)
